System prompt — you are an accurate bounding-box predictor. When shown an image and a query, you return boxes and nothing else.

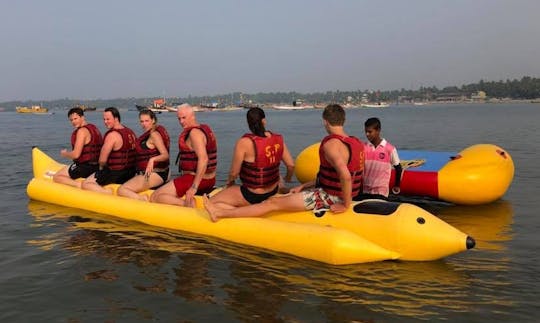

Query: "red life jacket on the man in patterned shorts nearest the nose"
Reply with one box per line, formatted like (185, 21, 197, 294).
(317, 135, 364, 198)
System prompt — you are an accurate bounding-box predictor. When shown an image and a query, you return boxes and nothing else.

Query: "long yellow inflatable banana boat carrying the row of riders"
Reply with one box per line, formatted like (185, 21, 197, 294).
(27, 147, 475, 265)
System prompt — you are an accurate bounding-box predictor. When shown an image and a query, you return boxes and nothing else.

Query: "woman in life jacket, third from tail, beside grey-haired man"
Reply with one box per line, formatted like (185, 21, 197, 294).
(118, 109, 171, 201)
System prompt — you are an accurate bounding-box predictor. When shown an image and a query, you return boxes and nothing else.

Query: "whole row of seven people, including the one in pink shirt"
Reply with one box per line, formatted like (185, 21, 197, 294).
(53, 104, 400, 222)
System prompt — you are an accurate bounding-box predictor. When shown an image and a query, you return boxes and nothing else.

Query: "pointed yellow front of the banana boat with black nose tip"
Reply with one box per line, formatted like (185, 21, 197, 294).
(270, 200, 476, 261)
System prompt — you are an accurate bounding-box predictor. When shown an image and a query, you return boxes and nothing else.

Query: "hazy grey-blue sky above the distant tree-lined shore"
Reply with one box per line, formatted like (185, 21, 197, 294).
(0, 0, 540, 102)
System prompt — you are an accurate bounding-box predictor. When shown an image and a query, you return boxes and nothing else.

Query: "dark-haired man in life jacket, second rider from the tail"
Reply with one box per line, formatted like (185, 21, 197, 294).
(82, 107, 137, 194)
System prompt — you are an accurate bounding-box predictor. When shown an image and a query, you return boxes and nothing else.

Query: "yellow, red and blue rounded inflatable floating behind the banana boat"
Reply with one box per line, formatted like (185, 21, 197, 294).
(295, 143, 514, 205)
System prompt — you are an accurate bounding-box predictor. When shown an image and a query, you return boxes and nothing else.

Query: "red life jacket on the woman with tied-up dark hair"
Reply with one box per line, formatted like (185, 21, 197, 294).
(240, 134, 284, 188)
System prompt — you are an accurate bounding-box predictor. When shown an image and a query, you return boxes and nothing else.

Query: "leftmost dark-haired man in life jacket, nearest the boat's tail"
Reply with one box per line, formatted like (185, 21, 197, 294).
(53, 108, 103, 188)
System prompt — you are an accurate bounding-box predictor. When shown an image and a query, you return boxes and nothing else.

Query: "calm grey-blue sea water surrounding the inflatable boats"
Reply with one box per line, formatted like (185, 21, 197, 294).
(0, 104, 540, 322)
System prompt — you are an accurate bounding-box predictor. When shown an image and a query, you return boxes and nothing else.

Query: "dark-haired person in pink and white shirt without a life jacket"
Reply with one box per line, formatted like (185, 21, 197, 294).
(354, 118, 402, 201)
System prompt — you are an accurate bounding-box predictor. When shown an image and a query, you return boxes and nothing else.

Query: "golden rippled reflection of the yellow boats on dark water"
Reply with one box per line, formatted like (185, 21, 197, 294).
(28, 201, 513, 321)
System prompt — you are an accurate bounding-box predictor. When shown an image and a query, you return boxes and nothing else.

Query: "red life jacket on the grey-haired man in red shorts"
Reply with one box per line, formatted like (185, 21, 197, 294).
(177, 124, 217, 174)
